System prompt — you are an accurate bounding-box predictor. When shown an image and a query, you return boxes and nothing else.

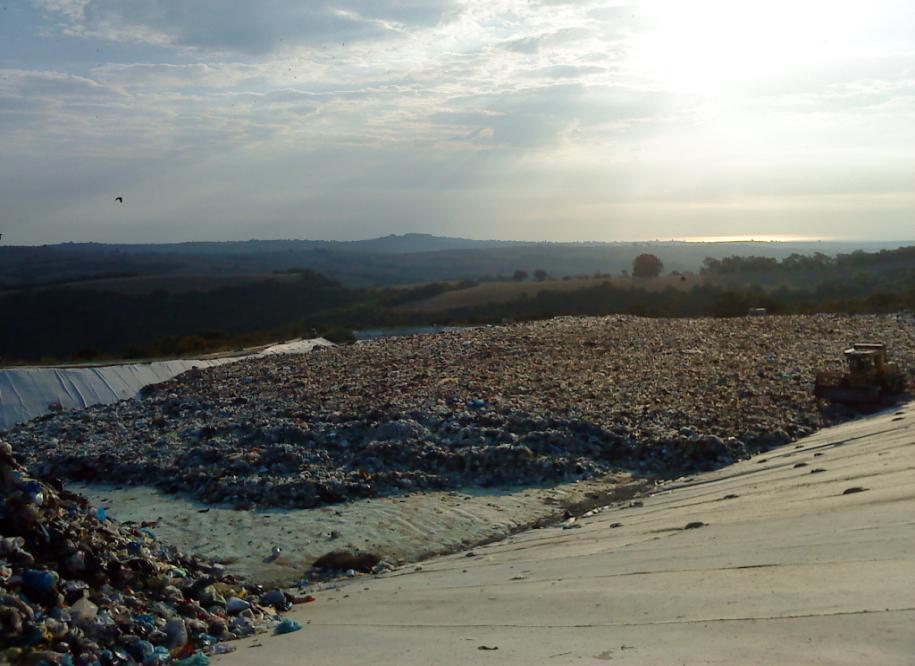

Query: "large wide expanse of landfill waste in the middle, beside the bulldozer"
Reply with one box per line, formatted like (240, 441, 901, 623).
(7, 315, 915, 508)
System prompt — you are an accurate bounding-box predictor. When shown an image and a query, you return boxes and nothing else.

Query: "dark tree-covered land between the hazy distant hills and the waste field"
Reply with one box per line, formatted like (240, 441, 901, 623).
(0, 248, 915, 363)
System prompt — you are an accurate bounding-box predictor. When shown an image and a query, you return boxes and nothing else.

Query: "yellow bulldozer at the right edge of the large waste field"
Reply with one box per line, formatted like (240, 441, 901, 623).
(813, 342, 906, 410)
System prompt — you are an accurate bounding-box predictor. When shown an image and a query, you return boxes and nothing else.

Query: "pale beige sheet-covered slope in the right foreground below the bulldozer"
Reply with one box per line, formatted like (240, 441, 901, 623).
(225, 403, 915, 666)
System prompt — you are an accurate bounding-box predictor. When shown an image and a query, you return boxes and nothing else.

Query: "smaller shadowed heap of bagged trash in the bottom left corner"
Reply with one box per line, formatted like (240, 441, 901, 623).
(0, 440, 308, 666)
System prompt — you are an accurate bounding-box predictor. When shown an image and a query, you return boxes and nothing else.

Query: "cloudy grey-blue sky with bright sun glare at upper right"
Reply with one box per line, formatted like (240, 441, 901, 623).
(0, 0, 915, 245)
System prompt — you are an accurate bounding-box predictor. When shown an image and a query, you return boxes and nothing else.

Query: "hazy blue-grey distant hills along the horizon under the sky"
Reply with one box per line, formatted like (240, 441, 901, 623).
(0, 233, 915, 288)
